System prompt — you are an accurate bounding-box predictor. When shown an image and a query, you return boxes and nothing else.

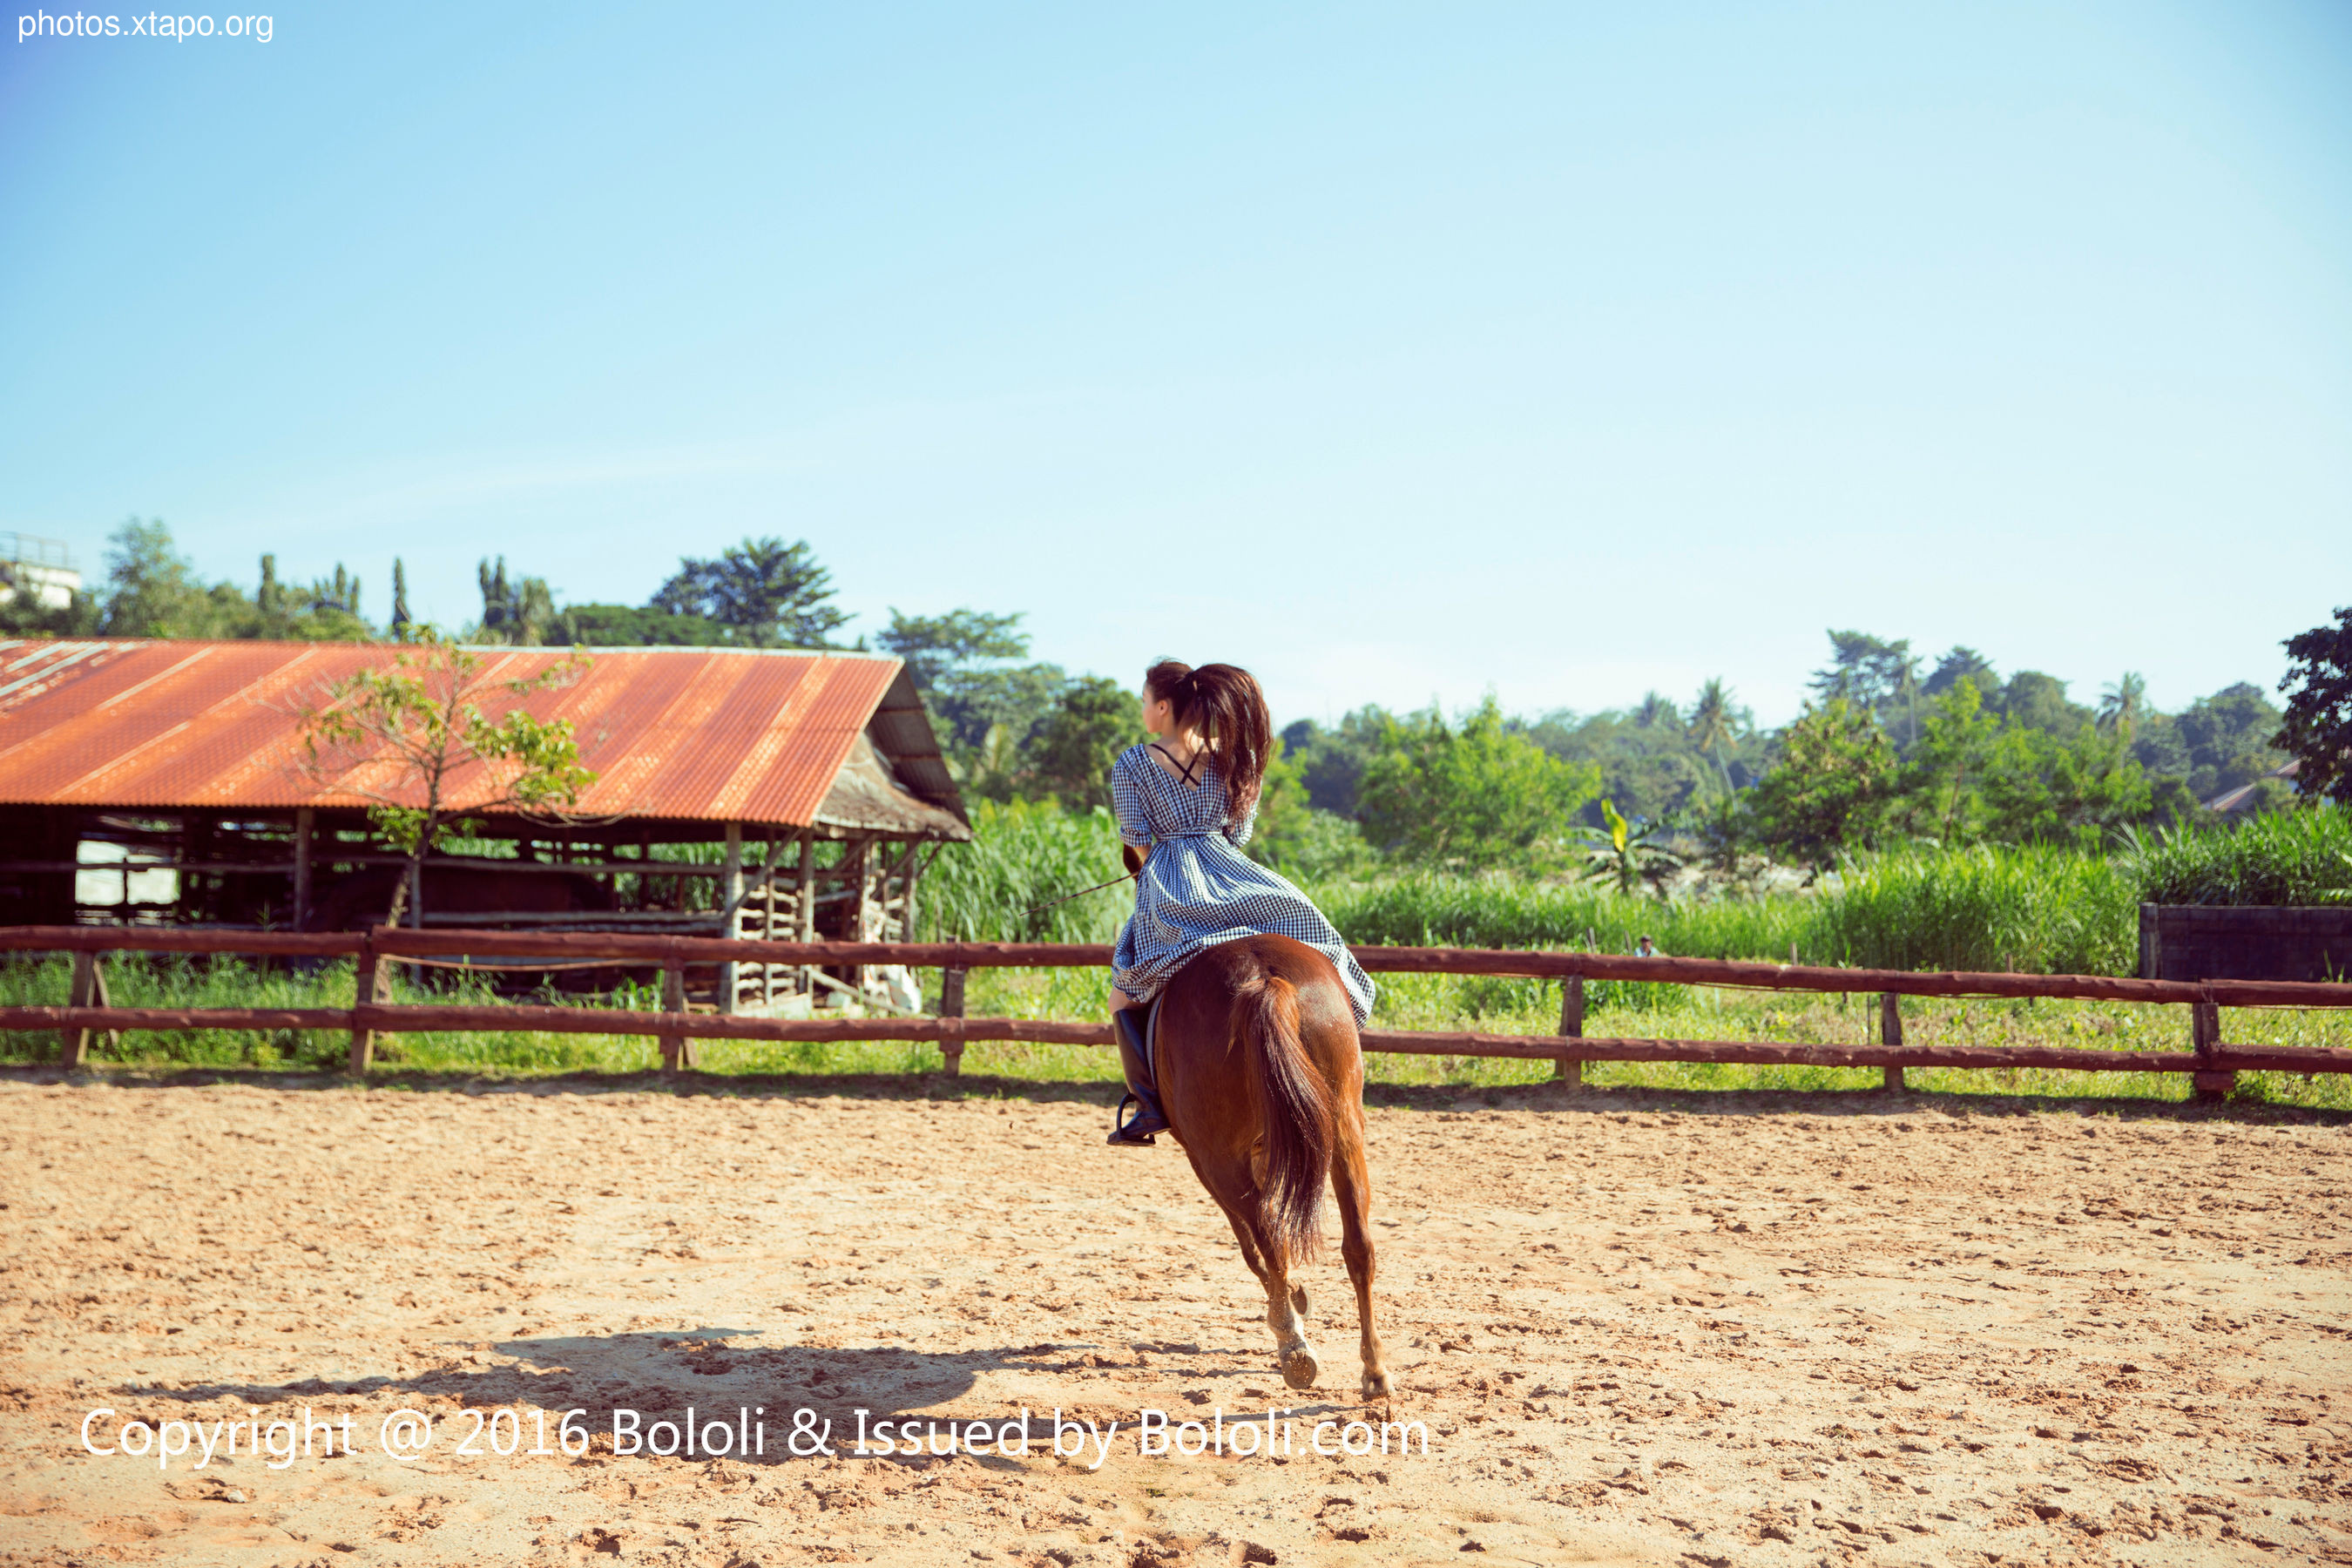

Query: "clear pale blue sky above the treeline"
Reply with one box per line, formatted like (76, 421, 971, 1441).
(0, 0, 2352, 721)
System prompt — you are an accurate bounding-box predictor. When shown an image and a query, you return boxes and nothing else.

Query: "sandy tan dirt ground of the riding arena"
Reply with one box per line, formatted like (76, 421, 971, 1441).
(0, 1072, 2352, 1568)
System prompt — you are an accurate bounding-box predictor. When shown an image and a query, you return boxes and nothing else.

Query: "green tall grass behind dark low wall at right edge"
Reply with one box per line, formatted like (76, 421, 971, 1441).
(2121, 801, 2352, 905)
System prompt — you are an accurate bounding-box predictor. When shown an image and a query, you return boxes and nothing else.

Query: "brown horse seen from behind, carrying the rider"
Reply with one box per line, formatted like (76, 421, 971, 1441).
(1152, 936, 1388, 1403)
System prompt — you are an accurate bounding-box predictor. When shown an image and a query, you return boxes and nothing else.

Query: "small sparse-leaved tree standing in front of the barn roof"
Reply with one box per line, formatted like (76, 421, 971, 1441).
(299, 628, 595, 926)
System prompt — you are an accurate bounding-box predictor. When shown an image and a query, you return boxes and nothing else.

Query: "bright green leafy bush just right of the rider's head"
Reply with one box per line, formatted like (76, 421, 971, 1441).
(1360, 696, 1599, 870)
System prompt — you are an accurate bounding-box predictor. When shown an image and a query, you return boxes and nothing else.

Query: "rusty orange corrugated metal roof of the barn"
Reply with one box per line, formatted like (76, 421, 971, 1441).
(0, 639, 898, 828)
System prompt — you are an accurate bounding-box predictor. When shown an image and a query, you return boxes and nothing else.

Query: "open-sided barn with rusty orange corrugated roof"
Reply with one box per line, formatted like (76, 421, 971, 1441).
(0, 639, 971, 1016)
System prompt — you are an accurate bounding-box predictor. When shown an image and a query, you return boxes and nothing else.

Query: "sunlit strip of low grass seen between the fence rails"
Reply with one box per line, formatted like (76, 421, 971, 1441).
(0, 956, 2352, 1110)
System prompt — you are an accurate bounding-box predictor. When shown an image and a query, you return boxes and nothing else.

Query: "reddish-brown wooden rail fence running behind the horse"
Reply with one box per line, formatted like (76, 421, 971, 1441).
(0, 926, 2352, 1096)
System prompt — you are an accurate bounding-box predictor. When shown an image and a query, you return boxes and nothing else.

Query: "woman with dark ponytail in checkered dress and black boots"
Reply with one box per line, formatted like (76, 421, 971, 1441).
(1110, 659, 1374, 1147)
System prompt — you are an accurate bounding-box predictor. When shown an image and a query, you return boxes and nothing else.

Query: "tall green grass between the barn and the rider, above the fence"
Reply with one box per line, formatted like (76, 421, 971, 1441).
(917, 801, 1136, 943)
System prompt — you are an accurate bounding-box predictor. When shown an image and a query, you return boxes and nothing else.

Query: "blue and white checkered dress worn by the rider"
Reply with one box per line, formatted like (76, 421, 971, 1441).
(1110, 745, 1374, 1025)
